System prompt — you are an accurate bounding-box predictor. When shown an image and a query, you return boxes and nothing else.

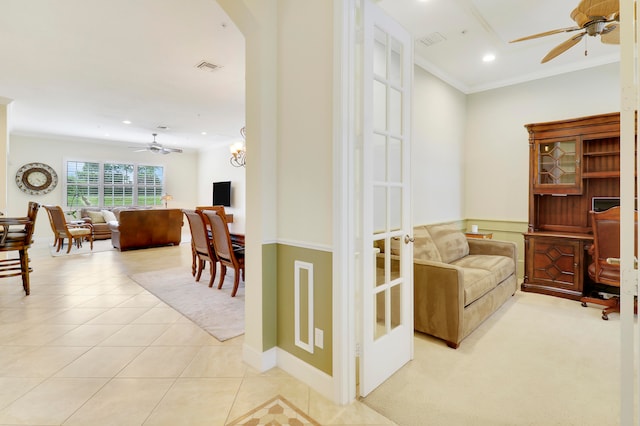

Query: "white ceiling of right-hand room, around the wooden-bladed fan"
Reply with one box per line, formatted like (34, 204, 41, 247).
(378, 0, 620, 93)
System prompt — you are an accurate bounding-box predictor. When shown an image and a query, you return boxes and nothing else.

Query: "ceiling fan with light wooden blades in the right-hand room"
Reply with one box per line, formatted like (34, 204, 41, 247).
(510, 0, 620, 64)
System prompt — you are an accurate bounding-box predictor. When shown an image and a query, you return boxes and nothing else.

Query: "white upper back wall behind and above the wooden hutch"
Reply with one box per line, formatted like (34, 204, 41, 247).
(462, 64, 620, 222)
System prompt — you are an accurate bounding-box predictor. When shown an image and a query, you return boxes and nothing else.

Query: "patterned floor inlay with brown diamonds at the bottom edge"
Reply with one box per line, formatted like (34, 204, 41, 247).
(229, 395, 320, 426)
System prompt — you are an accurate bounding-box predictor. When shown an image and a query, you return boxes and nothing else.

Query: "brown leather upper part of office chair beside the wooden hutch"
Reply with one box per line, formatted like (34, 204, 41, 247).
(588, 207, 638, 286)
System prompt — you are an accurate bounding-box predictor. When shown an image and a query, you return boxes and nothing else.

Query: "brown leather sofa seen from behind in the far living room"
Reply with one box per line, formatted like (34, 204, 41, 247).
(108, 209, 183, 251)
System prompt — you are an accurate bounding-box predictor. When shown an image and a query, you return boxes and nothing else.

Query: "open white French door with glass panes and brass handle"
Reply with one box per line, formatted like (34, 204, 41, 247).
(358, 0, 413, 396)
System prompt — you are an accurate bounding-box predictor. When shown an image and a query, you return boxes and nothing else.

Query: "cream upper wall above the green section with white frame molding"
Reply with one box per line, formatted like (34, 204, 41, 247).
(276, 0, 333, 247)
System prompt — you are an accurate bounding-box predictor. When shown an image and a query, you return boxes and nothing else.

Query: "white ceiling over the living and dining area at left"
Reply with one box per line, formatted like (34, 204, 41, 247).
(0, 0, 245, 152)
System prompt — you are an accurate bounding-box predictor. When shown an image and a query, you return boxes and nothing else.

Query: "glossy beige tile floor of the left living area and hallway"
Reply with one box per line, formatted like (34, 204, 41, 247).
(0, 241, 394, 426)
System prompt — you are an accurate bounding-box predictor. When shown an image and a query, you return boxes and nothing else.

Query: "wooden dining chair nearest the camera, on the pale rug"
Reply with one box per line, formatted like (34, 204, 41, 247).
(200, 207, 244, 297)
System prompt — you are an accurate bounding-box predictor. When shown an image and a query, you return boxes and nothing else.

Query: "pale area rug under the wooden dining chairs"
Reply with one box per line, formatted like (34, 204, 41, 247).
(131, 267, 244, 342)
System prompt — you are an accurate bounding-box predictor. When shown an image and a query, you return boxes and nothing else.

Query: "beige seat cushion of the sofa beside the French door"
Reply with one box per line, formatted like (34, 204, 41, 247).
(451, 254, 515, 306)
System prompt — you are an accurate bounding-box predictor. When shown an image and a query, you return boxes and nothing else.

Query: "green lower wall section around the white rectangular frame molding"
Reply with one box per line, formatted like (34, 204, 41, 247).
(276, 244, 333, 375)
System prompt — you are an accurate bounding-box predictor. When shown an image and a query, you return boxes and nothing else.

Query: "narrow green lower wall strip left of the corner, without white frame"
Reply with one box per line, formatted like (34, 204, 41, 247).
(262, 244, 278, 352)
